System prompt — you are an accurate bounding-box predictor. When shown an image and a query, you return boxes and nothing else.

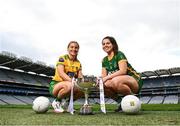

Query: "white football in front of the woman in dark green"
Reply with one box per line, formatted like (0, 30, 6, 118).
(121, 95, 141, 114)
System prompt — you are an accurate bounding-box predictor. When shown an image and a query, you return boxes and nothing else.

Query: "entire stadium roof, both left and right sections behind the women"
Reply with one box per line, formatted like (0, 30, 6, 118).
(0, 51, 180, 78)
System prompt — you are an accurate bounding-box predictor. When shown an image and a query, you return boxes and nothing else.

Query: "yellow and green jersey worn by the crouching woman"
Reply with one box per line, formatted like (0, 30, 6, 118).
(53, 54, 81, 81)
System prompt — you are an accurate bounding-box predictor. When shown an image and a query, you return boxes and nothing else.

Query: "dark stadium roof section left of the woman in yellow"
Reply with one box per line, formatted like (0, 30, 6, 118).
(0, 51, 54, 76)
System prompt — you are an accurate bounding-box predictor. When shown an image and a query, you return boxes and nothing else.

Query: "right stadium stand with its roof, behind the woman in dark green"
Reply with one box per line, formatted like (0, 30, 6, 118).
(140, 68, 180, 104)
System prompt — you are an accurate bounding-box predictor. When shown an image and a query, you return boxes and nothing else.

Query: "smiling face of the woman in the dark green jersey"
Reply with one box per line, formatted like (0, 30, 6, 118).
(102, 39, 113, 53)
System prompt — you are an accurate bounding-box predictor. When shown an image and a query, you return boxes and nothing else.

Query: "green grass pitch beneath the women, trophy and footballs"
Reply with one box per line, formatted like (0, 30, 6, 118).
(0, 104, 180, 125)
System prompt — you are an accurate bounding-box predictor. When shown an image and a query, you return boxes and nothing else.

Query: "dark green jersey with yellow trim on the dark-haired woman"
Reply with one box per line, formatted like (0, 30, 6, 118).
(102, 51, 140, 80)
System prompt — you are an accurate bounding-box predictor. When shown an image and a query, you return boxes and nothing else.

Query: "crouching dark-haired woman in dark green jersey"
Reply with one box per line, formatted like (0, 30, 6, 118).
(102, 36, 143, 110)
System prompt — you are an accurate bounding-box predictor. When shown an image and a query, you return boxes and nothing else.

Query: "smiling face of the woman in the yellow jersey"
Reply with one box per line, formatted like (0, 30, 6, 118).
(68, 41, 79, 57)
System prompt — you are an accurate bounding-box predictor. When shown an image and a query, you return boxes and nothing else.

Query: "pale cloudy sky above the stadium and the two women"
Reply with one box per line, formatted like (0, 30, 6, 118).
(0, 0, 180, 75)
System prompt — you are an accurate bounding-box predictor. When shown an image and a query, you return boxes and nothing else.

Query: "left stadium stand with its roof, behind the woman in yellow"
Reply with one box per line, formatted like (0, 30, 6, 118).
(0, 52, 54, 104)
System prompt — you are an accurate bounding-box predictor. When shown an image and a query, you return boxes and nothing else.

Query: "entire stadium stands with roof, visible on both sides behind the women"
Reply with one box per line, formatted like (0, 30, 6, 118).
(0, 51, 180, 105)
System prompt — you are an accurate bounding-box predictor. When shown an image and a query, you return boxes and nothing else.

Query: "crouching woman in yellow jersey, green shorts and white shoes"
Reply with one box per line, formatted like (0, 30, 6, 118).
(49, 41, 83, 113)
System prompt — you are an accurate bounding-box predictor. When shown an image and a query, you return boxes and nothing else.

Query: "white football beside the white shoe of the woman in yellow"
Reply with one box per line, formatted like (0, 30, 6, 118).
(32, 96, 50, 113)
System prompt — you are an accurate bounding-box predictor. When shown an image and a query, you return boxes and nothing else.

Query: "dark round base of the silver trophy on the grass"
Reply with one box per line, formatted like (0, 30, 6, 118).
(79, 105, 93, 115)
